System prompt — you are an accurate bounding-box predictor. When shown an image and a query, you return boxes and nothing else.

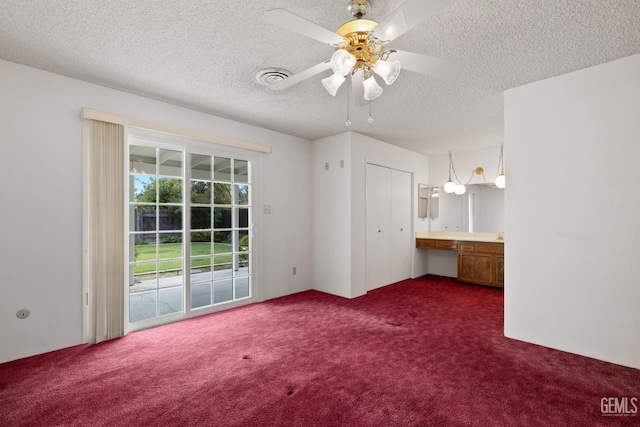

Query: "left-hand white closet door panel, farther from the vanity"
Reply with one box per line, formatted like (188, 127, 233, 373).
(365, 164, 391, 291)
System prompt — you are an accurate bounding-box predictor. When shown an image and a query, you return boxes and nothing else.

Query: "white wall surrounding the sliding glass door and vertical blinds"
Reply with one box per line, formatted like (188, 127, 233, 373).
(0, 61, 311, 362)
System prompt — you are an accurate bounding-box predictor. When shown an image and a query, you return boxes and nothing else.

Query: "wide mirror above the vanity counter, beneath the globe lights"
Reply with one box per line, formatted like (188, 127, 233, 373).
(432, 184, 504, 233)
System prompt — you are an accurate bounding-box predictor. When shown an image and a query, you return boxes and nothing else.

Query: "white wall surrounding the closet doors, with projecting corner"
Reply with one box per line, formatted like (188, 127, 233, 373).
(313, 132, 429, 298)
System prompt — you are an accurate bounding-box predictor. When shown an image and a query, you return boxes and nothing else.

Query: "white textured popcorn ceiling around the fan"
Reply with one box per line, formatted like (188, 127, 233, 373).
(0, 0, 640, 154)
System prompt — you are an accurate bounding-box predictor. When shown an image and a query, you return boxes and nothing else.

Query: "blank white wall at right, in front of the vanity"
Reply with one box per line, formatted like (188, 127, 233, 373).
(505, 51, 640, 368)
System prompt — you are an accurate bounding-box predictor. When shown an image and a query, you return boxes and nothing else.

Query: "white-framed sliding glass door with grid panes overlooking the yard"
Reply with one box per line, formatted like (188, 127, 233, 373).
(127, 137, 253, 329)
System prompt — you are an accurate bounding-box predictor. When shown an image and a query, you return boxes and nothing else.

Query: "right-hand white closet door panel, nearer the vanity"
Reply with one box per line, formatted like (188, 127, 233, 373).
(388, 169, 413, 283)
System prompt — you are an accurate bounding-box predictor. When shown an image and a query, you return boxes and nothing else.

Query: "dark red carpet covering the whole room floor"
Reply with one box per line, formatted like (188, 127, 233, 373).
(0, 276, 640, 427)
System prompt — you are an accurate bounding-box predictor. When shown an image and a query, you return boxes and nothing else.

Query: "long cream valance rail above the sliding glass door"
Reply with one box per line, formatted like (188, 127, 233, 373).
(82, 107, 271, 154)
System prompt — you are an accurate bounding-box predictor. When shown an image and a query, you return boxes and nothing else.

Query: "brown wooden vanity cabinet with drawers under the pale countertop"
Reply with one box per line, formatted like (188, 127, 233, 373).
(416, 239, 504, 287)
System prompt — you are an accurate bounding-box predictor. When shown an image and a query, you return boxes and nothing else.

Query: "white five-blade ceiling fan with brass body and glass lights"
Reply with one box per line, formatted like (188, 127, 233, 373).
(264, 0, 462, 125)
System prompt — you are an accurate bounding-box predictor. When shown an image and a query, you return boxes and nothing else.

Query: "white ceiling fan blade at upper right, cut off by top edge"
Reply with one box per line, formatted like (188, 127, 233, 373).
(372, 0, 455, 41)
